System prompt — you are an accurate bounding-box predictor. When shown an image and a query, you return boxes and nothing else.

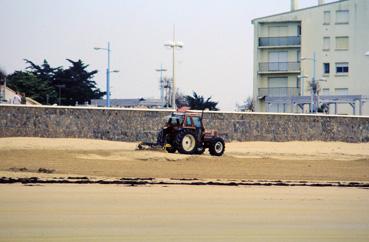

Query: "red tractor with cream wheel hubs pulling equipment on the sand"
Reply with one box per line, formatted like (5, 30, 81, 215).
(138, 112, 225, 156)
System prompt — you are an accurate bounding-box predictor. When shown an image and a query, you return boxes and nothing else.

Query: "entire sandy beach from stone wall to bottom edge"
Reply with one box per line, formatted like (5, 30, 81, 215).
(0, 138, 369, 242)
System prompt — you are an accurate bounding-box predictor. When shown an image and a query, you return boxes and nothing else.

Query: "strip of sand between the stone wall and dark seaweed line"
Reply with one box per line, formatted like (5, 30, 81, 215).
(0, 138, 369, 182)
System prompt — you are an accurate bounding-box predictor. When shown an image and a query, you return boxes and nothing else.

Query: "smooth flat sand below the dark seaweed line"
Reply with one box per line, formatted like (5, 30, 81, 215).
(0, 184, 369, 242)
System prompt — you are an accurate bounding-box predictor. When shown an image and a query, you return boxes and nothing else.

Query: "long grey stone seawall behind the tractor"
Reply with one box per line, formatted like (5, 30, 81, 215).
(0, 105, 369, 142)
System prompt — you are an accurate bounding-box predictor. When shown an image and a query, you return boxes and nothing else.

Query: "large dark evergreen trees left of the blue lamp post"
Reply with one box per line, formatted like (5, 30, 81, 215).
(8, 59, 105, 105)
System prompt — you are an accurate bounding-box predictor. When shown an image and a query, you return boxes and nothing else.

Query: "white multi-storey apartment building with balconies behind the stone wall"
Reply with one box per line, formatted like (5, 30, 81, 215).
(252, 0, 369, 115)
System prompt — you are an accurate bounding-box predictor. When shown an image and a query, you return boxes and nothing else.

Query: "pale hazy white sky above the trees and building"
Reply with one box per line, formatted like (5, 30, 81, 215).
(0, 0, 334, 110)
